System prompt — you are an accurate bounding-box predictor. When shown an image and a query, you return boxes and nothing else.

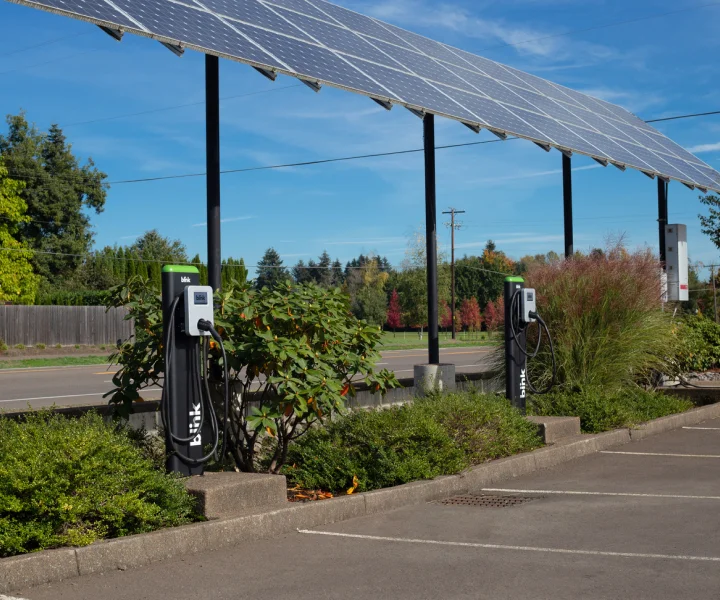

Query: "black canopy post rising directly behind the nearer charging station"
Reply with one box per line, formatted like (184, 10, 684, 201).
(205, 54, 222, 290)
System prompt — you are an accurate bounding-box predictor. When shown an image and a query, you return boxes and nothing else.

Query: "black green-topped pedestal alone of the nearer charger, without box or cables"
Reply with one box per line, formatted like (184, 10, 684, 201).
(162, 265, 203, 476)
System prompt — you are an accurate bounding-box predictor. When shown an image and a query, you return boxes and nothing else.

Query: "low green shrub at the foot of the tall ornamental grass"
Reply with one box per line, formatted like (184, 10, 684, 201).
(528, 386, 693, 433)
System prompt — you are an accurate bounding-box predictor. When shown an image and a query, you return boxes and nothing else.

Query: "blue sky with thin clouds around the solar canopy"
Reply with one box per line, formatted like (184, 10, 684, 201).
(0, 0, 720, 276)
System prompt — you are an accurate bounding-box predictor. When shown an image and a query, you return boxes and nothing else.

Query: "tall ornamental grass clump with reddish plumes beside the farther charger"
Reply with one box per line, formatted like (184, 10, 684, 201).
(527, 244, 677, 390)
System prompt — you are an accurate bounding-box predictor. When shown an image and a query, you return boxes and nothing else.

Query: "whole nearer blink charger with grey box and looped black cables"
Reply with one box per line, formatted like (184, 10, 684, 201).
(161, 265, 229, 476)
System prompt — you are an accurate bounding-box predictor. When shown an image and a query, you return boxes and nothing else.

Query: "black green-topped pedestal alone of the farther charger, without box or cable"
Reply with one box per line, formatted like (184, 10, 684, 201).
(505, 277, 527, 414)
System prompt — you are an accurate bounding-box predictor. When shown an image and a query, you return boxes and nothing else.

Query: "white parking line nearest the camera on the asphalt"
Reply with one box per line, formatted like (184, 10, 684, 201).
(298, 529, 720, 562)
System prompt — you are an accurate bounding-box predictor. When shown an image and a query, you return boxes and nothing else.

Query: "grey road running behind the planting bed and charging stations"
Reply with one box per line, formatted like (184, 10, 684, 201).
(0, 347, 490, 411)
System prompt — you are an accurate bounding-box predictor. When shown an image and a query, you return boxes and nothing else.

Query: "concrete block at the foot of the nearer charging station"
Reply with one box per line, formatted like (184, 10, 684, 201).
(185, 471, 287, 519)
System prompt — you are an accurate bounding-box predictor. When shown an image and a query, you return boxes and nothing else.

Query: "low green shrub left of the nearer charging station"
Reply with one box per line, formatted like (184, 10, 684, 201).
(0, 413, 193, 557)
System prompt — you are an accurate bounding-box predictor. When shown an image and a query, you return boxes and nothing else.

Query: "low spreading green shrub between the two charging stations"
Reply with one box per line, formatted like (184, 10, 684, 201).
(284, 392, 540, 493)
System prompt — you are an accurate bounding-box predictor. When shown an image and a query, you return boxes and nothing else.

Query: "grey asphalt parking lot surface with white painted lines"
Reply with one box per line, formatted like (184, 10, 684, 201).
(13, 419, 720, 600)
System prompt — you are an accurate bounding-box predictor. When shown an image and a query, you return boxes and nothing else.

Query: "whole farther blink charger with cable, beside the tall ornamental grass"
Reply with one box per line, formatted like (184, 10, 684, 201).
(504, 277, 557, 413)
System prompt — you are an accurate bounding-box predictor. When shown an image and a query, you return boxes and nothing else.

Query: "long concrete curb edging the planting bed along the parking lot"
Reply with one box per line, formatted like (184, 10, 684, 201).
(0, 404, 720, 594)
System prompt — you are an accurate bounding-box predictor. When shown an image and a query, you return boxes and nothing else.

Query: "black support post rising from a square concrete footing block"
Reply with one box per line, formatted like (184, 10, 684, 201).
(423, 114, 440, 365)
